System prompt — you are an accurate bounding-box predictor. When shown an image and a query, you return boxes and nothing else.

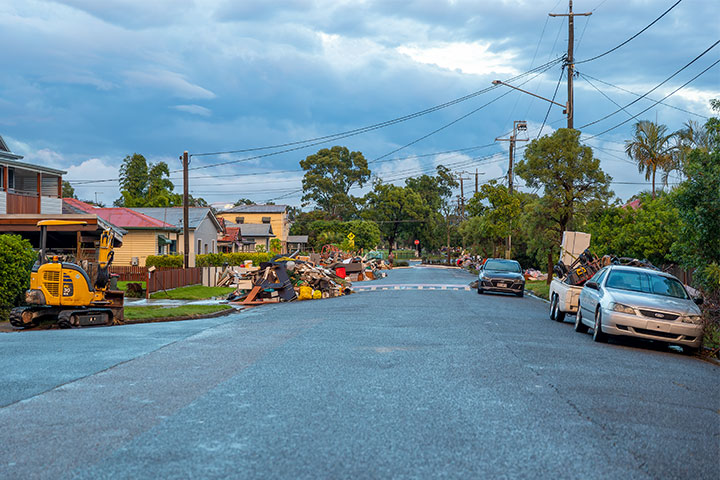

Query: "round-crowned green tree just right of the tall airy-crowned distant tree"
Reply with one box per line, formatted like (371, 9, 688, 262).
(364, 183, 427, 254)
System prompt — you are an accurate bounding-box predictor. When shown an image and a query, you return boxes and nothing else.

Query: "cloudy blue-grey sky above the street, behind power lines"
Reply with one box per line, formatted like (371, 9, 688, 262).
(0, 0, 720, 205)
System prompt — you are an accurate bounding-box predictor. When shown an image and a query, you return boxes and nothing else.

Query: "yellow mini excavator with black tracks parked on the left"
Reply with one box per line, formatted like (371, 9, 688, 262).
(10, 220, 123, 328)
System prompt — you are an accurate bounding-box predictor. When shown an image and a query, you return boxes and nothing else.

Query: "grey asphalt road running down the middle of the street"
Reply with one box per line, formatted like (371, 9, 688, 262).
(0, 268, 720, 479)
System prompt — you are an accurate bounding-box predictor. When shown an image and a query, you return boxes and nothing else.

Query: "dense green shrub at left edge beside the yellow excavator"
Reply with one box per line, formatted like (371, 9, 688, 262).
(0, 235, 37, 320)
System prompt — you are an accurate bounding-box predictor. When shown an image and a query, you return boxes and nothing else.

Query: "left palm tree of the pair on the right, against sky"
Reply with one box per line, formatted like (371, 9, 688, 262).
(625, 120, 675, 198)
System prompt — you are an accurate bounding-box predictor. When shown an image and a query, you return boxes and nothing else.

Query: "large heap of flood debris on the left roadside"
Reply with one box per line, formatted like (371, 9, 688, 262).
(224, 252, 390, 305)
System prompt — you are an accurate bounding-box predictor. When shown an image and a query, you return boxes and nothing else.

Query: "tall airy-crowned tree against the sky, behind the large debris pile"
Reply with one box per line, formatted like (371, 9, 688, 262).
(300, 146, 370, 218)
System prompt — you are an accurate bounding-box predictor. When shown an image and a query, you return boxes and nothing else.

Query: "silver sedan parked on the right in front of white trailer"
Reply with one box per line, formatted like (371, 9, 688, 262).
(575, 265, 703, 352)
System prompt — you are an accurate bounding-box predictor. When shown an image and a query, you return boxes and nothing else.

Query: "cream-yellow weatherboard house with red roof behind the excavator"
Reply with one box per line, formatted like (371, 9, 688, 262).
(63, 198, 180, 266)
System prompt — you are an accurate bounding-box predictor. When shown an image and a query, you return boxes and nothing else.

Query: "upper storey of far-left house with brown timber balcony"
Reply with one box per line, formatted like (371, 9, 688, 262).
(0, 136, 67, 215)
